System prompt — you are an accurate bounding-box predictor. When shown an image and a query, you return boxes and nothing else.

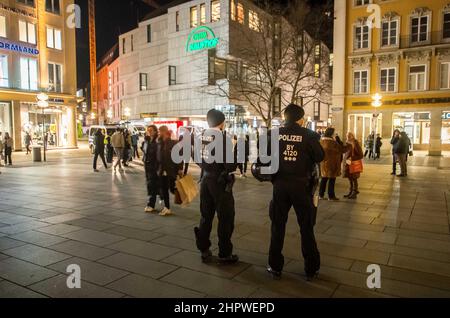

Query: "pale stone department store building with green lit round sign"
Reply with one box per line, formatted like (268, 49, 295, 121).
(119, 0, 331, 131)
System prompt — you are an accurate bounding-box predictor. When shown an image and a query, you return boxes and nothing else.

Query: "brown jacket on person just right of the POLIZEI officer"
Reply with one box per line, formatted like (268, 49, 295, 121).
(320, 137, 349, 178)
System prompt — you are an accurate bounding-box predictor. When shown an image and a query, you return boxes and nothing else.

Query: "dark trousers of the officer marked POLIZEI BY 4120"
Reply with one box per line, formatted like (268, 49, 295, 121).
(269, 177, 320, 275)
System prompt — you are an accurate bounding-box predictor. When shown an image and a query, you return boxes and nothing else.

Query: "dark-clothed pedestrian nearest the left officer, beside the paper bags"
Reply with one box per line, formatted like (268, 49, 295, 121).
(157, 126, 183, 216)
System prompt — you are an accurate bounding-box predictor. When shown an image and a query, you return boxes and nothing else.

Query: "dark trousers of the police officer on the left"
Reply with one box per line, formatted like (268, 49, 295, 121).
(197, 175, 235, 258)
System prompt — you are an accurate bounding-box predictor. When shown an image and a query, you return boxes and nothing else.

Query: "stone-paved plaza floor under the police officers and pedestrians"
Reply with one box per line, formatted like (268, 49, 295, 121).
(0, 150, 450, 298)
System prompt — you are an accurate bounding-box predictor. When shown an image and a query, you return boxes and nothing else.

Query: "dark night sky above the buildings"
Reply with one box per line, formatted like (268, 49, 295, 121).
(75, 0, 332, 88)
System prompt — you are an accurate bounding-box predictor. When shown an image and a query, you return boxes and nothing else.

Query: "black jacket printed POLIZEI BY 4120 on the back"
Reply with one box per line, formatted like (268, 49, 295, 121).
(269, 124, 325, 179)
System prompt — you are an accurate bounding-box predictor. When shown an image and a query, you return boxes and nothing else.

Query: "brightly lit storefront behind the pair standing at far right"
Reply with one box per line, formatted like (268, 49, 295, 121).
(392, 112, 431, 146)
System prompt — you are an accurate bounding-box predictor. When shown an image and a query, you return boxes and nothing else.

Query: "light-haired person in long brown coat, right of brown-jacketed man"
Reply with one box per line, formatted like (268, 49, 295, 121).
(342, 132, 364, 200)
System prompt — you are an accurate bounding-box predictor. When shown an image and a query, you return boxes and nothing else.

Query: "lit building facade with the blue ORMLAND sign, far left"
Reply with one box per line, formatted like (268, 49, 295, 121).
(0, 0, 77, 151)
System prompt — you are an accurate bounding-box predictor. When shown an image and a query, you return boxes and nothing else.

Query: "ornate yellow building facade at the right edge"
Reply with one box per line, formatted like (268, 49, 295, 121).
(332, 0, 450, 155)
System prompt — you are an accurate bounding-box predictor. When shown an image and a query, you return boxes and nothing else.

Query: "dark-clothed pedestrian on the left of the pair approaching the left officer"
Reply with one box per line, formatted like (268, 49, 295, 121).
(141, 125, 160, 213)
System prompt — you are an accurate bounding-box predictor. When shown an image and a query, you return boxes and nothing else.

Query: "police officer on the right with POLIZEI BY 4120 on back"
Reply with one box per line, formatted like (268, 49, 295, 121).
(267, 104, 325, 280)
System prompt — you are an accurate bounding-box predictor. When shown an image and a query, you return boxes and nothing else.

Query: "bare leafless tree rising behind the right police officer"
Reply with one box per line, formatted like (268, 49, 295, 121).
(202, 0, 331, 127)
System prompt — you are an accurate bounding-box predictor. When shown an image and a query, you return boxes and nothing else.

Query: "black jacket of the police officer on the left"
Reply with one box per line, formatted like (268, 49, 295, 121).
(199, 130, 237, 177)
